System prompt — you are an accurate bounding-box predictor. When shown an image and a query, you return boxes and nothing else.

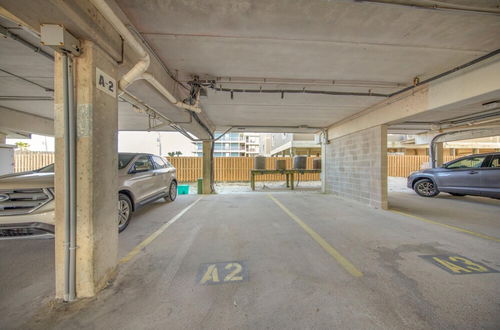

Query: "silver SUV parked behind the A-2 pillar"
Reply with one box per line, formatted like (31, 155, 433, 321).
(0, 153, 177, 239)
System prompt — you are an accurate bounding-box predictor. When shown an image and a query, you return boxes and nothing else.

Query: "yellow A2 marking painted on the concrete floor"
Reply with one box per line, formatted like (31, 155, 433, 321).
(197, 261, 248, 284)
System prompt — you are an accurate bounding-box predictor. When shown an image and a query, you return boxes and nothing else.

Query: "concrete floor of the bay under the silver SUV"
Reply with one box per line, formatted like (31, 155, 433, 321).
(0, 195, 199, 329)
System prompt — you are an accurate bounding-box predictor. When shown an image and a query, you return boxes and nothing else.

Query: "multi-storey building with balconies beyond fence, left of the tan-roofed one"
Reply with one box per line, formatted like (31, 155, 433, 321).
(195, 132, 261, 157)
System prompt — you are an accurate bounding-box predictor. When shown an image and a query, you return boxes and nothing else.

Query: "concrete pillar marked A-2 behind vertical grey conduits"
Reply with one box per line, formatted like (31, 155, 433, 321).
(54, 41, 118, 298)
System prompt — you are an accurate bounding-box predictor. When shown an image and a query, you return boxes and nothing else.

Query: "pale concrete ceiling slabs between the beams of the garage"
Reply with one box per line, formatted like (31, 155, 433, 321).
(0, 0, 500, 136)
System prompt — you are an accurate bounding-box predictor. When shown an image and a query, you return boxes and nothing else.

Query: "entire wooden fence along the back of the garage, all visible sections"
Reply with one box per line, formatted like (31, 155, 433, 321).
(14, 150, 458, 182)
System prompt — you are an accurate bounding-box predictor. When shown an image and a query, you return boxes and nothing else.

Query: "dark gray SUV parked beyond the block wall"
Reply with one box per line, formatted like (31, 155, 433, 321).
(407, 152, 500, 199)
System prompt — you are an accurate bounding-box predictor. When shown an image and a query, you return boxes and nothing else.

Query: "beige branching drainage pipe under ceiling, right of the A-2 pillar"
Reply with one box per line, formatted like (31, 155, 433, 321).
(90, 0, 201, 113)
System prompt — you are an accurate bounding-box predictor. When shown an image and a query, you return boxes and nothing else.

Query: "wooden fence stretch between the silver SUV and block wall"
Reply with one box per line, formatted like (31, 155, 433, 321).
(168, 157, 319, 182)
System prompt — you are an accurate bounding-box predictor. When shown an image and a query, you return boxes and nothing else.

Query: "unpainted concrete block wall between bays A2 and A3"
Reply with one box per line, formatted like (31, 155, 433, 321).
(324, 126, 387, 209)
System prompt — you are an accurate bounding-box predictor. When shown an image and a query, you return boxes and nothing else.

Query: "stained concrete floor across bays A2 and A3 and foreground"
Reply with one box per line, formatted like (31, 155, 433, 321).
(0, 192, 500, 329)
